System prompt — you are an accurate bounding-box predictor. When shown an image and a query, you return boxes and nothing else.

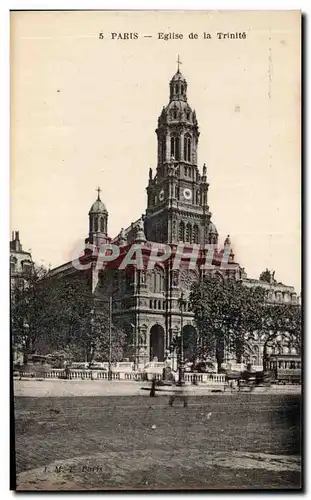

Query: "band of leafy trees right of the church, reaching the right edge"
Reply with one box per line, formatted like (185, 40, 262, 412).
(190, 277, 301, 370)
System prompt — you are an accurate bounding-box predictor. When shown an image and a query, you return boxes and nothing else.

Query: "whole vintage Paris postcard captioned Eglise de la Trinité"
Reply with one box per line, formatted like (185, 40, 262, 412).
(10, 11, 302, 491)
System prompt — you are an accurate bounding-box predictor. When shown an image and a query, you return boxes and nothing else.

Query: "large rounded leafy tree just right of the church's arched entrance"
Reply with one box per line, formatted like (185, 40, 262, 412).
(190, 277, 264, 371)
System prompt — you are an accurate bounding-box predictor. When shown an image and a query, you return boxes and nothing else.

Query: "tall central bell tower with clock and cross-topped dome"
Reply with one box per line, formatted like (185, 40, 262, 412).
(145, 56, 218, 245)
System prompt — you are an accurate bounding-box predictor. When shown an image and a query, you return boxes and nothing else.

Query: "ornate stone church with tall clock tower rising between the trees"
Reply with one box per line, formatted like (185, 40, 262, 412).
(50, 68, 295, 364)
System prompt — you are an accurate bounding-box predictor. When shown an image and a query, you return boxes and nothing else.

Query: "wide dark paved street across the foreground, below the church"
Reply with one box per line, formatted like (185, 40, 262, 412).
(15, 393, 300, 490)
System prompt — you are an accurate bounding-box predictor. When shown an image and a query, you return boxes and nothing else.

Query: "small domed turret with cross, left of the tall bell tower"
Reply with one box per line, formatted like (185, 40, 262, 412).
(88, 187, 108, 247)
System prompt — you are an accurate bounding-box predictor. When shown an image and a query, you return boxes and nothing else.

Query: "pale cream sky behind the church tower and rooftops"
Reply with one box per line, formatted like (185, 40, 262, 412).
(11, 11, 301, 293)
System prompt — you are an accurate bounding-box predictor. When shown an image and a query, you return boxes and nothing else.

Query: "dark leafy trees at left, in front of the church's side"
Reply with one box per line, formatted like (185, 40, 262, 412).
(12, 275, 125, 363)
